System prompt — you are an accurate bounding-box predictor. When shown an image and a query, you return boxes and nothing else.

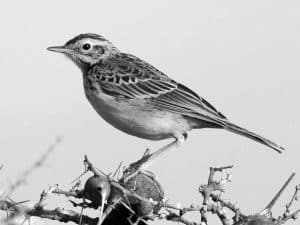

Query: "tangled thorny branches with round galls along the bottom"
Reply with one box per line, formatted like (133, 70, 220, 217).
(0, 155, 300, 225)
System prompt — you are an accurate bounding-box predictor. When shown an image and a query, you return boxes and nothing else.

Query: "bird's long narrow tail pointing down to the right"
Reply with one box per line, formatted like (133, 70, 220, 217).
(222, 120, 284, 153)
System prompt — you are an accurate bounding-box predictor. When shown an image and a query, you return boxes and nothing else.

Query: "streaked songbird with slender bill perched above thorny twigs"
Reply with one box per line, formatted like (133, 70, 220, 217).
(47, 33, 284, 156)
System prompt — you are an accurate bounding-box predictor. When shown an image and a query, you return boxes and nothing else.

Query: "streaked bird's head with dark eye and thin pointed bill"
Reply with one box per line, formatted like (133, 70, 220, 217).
(47, 33, 118, 69)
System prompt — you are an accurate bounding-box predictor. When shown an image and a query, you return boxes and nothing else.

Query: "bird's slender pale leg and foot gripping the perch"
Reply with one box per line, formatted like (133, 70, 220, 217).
(124, 134, 187, 181)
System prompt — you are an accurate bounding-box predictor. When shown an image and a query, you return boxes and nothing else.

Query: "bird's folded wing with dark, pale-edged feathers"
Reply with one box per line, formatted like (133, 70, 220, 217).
(93, 53, 226, 122)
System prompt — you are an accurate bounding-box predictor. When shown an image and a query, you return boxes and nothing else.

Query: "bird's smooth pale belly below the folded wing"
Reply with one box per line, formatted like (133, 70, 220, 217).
(86, 90, 189, 140)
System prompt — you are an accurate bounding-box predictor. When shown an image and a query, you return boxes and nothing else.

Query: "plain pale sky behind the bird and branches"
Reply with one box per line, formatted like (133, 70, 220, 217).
(0, 0, 300, 224)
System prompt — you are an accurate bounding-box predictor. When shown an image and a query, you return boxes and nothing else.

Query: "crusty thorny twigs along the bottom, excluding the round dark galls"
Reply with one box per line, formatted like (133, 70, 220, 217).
(0, 154, 300, 225)
